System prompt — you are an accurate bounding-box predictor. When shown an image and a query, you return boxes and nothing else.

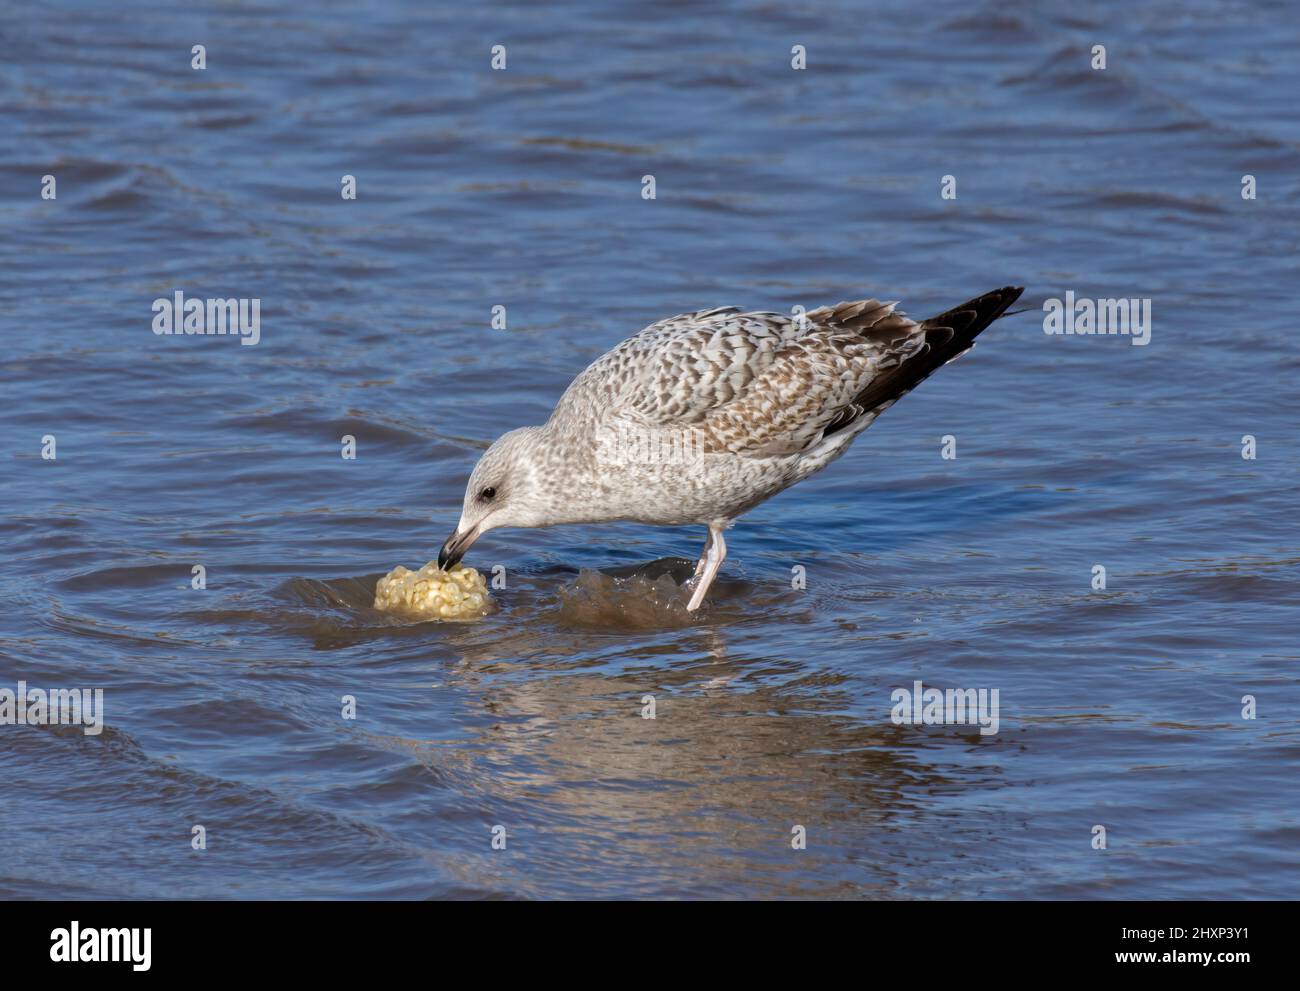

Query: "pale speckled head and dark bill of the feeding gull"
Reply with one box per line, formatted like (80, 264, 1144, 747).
(438, 427, 563, 570)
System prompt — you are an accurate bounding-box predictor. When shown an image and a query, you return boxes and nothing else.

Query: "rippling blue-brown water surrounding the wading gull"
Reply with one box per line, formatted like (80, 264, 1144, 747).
(0, 0, 1300, 899)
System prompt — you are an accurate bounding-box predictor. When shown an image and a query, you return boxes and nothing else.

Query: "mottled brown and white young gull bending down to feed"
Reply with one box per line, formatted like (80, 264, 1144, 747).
(438, 286, 1023, 611)
